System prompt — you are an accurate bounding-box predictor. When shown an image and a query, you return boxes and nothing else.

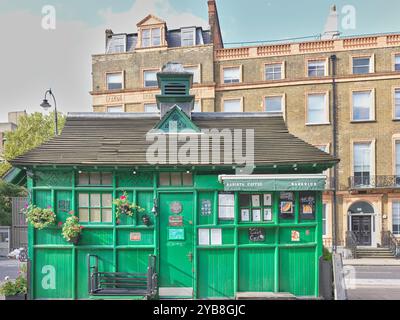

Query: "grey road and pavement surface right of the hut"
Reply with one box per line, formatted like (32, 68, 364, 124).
(343, 259, 400, 300)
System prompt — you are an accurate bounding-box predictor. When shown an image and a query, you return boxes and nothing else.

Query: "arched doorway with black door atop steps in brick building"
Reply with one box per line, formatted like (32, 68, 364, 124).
(348, 201, 375, 246)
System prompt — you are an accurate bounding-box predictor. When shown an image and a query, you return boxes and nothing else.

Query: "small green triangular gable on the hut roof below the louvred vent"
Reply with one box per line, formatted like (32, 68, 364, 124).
(153, 105, 200, 133)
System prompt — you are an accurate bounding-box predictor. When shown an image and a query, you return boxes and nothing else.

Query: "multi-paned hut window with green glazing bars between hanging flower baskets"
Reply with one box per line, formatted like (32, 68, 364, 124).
(78, 191, 113, 224)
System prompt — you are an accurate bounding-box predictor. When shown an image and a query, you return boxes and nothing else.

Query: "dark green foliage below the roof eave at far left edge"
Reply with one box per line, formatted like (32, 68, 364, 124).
(0, 180, 28, 226)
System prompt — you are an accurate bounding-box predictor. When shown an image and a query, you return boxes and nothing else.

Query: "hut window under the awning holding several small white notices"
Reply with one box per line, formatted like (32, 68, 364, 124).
(239, 192, 274, 223)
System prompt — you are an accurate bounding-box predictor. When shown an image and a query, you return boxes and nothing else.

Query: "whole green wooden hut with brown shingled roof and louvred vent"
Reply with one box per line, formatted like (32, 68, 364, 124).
(13, 64, 337, 299)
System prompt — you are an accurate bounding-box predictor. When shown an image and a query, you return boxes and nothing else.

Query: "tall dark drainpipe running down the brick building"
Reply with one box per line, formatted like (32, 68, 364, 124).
(330, 55, 339, 253)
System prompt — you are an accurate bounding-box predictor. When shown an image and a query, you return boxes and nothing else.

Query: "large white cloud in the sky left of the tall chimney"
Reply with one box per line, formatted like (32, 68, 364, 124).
(0, 0, 208, 122)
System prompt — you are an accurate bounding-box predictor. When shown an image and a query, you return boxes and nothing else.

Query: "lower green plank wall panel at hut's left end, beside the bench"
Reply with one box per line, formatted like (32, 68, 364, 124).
(34, 249, 72, 299)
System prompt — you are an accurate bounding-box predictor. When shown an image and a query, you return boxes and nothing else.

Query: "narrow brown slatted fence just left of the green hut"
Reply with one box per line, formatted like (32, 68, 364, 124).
(11, 198, 29, 250)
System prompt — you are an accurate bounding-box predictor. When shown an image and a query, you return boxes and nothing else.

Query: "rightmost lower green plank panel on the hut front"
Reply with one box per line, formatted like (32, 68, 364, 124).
(279, 247, 317, 296)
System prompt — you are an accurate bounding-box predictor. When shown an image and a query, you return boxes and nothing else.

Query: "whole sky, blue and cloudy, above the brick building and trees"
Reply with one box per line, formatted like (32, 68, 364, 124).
(0, 0, 400, 122)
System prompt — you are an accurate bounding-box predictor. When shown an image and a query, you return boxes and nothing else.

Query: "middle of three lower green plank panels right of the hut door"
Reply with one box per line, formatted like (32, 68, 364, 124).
(238, 248, 275, 292)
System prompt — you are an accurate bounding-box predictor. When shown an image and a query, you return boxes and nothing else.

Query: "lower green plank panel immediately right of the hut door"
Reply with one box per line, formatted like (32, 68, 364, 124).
(197, 249, 235, 299)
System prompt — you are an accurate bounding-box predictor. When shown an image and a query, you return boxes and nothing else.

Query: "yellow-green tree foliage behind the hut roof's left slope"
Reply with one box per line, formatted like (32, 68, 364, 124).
(0, 112, 65, 177)
